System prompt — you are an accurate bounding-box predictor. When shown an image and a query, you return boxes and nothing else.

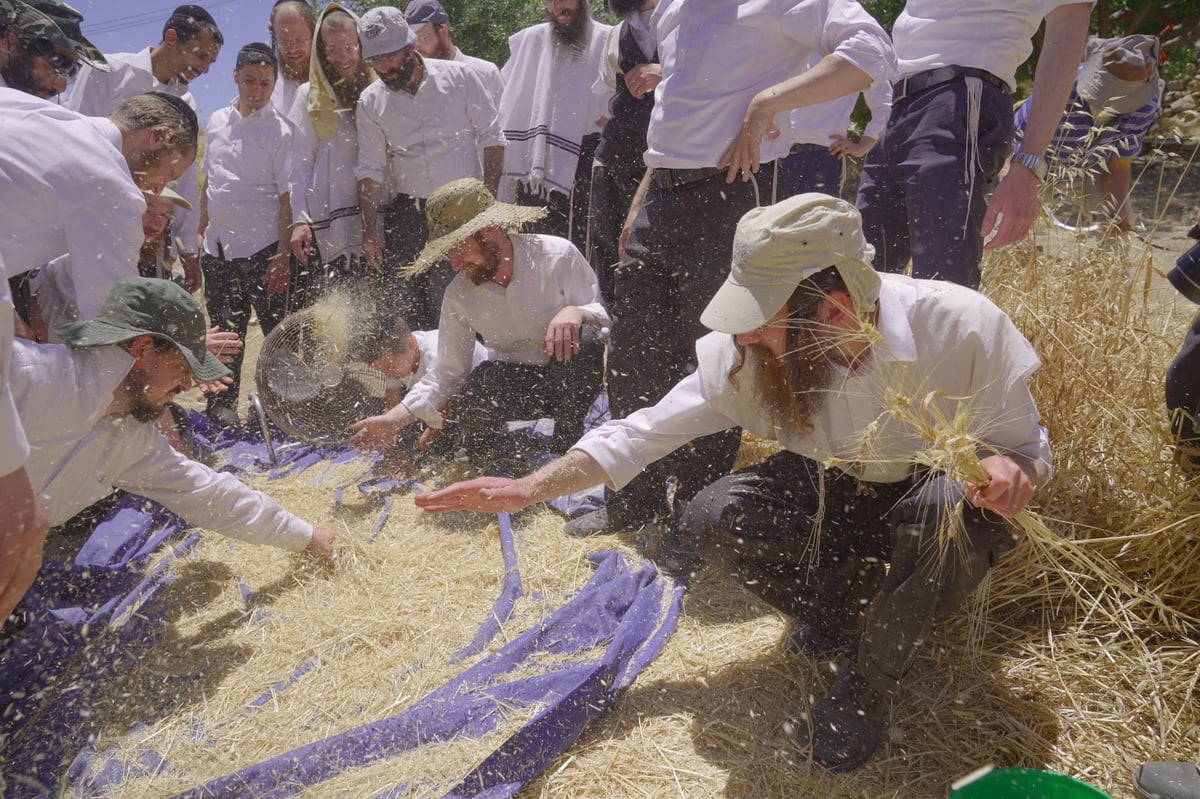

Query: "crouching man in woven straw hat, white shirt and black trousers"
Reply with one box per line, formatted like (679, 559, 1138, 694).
(350, 178, 611, 465)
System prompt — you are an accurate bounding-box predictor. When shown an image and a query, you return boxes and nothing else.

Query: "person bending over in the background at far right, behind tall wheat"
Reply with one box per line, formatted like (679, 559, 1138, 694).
(1015, 34, 1163, 230)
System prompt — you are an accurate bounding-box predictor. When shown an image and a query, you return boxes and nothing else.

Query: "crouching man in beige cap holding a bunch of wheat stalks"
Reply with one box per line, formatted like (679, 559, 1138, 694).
(416, 193, 1050, 770)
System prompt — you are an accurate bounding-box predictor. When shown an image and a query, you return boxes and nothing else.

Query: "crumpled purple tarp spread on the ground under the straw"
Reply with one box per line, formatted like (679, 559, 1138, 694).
(0, 414, 683, 799)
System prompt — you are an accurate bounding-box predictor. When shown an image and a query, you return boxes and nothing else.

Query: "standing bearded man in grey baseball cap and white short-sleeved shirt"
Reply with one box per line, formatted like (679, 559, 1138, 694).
(355, 7, 504, 329)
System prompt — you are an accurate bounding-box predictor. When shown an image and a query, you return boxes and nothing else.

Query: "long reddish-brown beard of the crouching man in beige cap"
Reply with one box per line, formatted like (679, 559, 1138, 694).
(730, 321, 836, 432)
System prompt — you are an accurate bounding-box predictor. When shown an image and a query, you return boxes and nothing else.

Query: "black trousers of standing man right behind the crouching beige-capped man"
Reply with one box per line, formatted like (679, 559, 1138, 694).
(606, 163, 776, 528)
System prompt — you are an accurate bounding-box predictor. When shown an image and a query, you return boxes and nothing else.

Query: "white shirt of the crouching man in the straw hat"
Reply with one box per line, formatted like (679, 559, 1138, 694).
(402, 233, 612, 427)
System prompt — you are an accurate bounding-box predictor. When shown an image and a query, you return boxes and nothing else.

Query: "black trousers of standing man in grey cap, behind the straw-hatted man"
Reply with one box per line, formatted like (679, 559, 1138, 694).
(379, 194, 454, 330)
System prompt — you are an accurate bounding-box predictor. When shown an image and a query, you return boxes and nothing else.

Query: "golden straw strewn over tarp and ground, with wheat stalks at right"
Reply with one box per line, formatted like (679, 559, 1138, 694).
(79, 155, 1200, 799)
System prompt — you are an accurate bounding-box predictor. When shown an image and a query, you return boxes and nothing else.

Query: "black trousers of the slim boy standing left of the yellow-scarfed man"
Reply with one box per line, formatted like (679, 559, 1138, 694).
(200, 244, 288, 409)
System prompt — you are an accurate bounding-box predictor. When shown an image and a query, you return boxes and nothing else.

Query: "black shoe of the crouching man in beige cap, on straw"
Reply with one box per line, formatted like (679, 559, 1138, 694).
(799, 656, 888, 771)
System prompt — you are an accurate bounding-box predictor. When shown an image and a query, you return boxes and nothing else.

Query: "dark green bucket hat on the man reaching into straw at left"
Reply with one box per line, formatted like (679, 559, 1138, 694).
(54, 277, 229, 382)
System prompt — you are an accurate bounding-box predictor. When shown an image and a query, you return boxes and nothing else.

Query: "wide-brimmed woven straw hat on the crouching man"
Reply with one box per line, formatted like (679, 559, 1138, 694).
(402, 178, 547, 277)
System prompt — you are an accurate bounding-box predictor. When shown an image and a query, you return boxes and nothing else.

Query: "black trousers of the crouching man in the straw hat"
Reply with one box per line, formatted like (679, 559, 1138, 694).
(451, 326, 605, 465)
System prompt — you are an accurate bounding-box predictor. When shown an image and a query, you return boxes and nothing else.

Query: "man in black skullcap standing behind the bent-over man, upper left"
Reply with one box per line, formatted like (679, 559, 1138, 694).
(67, 5, 224, 291)
